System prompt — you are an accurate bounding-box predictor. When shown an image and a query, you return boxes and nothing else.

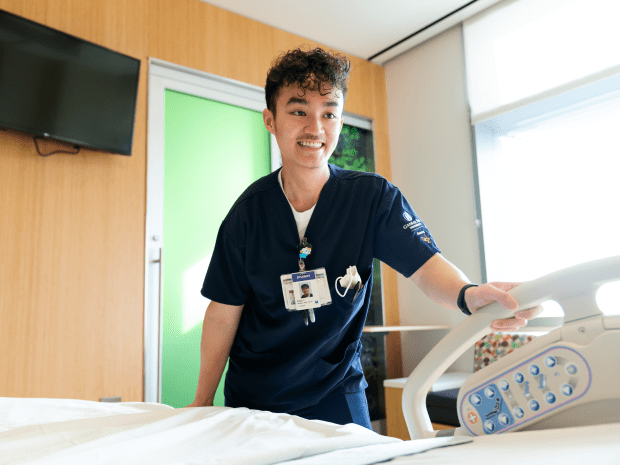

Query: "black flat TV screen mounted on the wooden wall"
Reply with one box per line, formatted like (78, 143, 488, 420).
(0, 10, 140, 155)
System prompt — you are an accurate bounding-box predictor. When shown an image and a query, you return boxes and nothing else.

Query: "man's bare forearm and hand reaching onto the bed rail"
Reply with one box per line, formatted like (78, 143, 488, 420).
(411, 254, 540, 331)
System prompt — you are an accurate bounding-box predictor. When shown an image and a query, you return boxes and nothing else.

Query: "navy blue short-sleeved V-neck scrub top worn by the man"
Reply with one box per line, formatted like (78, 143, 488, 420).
(201, 165, 439, 412)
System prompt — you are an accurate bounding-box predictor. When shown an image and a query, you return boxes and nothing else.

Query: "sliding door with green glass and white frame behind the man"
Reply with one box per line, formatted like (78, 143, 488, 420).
(144, 60, 280, 407)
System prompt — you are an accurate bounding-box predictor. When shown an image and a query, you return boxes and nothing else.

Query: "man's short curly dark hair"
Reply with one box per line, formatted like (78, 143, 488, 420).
(265, 47, 351, 116)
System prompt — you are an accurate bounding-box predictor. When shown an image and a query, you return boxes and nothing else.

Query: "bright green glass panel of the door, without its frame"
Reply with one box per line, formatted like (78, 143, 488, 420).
(162, 90, 271, 407)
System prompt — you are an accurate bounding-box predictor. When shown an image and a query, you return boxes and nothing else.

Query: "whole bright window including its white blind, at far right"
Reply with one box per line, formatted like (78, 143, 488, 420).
(463, 0, 620, 316)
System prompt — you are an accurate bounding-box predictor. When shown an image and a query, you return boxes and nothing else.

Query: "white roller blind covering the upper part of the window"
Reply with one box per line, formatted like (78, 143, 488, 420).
(463, 0, 620, 123)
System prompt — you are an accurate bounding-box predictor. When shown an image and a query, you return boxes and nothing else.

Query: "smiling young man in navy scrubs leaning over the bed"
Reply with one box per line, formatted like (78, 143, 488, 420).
(191, 49, 530, 428)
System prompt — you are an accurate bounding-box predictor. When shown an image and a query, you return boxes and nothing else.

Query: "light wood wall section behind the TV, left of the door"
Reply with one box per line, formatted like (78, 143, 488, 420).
(0, 0, 147, 400)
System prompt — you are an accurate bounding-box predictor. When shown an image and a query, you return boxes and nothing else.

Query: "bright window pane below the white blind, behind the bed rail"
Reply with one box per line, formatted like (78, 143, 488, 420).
(475, 72, 620, 317)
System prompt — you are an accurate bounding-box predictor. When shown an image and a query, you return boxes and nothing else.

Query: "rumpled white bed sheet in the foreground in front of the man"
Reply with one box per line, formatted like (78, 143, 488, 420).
(0, 398, 470, 465)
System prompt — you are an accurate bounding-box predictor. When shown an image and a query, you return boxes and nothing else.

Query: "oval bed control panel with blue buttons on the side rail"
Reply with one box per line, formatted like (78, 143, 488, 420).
(459, 346, 592, 436)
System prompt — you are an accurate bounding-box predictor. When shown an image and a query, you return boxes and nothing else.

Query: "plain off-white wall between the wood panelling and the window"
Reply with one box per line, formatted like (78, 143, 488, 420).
(386, 25, 481, 376)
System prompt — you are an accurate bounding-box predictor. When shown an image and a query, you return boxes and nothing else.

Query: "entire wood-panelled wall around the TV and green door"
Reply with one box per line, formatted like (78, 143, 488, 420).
(0, 0, 401, 401)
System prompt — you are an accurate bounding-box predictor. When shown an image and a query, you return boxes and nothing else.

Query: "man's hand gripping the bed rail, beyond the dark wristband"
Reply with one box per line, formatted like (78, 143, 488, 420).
(465, 283, 542, 331)
